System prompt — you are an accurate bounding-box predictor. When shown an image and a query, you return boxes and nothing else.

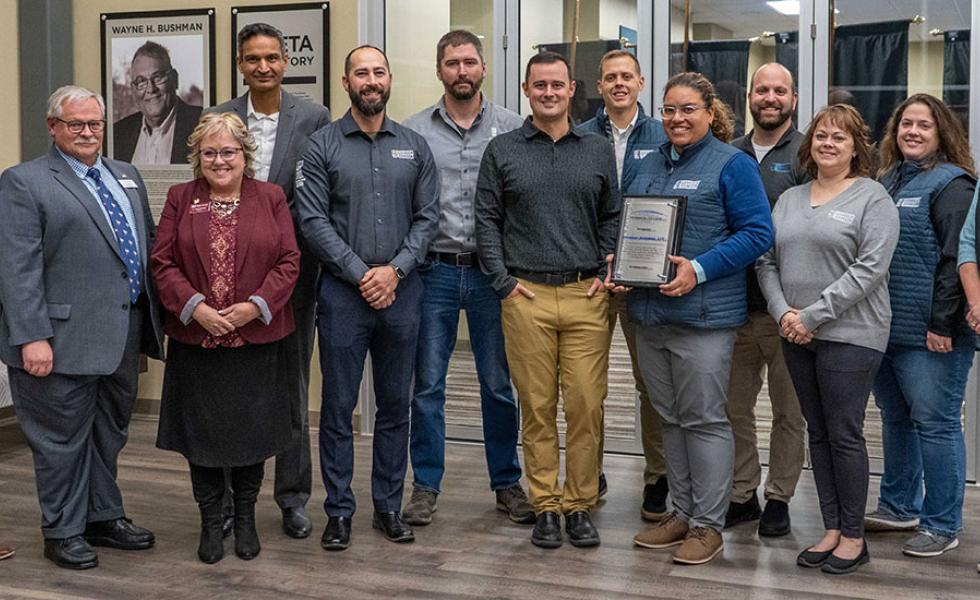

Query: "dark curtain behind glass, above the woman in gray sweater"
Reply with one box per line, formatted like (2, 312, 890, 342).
(829, 20, 909, 140)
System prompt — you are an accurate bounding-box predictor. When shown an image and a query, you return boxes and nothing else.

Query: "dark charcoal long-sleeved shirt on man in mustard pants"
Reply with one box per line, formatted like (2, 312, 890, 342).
(476, 117, 622, 297)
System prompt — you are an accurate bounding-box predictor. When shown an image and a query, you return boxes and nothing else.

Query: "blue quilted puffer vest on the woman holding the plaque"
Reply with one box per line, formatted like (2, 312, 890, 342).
(627, 131, 748, 329)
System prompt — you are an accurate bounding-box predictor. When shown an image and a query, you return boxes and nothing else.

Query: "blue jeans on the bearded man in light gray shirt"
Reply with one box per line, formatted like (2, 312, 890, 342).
(410, 262, 521, 492)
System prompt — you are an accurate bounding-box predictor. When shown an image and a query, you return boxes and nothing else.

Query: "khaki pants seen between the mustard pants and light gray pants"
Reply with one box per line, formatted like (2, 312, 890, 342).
(599, 294, 667, 485)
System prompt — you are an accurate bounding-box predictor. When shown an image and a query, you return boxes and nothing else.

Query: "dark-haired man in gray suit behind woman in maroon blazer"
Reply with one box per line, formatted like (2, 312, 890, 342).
(211, 23, 330, 538)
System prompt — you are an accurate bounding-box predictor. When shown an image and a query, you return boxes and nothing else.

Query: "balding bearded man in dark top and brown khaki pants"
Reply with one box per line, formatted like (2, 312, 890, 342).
(725, 63, 808, 536)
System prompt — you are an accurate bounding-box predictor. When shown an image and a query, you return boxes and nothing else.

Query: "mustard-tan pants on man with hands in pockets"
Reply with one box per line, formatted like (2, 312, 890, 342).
(501, 278, 609, 514)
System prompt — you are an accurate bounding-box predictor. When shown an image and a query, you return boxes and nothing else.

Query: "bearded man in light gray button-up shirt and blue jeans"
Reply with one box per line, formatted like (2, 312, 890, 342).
(403, 30, 534, 525)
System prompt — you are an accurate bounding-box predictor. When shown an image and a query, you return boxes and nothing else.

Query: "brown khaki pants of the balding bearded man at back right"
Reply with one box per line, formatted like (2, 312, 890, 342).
(727, 312, 806, 502)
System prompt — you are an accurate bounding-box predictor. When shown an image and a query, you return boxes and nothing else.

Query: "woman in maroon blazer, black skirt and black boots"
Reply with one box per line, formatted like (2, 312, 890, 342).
(150, 113, 299, 563)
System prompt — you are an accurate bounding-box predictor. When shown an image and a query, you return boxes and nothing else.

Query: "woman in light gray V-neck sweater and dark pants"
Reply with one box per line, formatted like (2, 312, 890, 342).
(756, 104, 899, 574)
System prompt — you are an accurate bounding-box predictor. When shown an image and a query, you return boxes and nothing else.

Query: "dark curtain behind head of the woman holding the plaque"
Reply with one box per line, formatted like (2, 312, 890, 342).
(671, 40, 751, 137)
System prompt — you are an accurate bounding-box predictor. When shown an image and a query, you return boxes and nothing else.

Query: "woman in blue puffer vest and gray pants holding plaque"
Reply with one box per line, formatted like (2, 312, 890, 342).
(627, 73, 772, 564)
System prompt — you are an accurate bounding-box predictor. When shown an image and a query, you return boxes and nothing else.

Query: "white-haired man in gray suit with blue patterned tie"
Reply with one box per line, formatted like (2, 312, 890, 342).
(0, 86, 163, 569)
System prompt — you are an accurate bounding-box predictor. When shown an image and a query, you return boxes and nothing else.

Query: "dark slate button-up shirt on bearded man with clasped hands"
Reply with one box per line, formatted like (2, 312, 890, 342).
(295, 110, 439, 285)
